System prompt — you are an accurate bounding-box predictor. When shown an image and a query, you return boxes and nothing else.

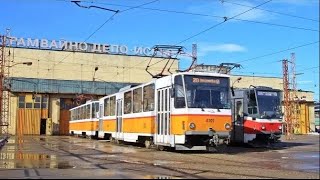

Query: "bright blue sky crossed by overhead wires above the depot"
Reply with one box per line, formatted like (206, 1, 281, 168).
(0, 0, 319, 100)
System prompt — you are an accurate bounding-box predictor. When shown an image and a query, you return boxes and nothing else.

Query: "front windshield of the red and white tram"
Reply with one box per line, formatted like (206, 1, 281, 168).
(256, 91, 281, 118)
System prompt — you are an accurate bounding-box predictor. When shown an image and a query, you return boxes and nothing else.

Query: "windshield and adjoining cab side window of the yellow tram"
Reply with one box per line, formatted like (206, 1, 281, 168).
(175, 75, 230, 109)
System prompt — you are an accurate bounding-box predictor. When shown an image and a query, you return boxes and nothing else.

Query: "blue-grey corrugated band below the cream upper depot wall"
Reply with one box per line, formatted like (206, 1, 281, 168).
(10, 78, 134, 95)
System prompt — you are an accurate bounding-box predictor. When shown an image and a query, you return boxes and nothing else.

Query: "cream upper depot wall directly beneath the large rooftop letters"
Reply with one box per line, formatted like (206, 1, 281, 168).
(11, 48, 178, 83)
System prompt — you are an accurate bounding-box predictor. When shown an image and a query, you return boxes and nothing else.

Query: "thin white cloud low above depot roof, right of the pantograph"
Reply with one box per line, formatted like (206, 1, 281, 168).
(198, 43, 247, 56)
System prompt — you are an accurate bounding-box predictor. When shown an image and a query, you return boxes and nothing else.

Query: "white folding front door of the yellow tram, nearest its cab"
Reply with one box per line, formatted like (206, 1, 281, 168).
(155, 88, 171, 144)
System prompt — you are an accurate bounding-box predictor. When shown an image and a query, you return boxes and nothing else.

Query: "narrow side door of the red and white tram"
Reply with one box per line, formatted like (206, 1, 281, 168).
(233, 98, 244, 143)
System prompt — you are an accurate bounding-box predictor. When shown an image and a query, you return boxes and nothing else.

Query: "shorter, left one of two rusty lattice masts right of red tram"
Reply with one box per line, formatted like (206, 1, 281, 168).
(282, 59, 292, 139)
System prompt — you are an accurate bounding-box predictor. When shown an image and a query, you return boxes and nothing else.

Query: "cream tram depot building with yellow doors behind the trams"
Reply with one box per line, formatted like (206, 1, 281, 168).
(6, 38, 315, 135)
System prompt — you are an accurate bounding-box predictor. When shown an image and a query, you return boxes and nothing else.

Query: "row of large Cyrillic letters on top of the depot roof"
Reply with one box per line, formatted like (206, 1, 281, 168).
(0, 36, 153, 56)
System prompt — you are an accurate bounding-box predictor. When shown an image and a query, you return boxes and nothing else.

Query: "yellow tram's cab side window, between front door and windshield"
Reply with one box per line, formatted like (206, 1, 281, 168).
(174, 76, 186, 108)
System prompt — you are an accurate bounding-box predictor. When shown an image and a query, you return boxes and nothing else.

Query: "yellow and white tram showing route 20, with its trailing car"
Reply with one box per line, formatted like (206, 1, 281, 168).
(70, 72, 231, 150)
